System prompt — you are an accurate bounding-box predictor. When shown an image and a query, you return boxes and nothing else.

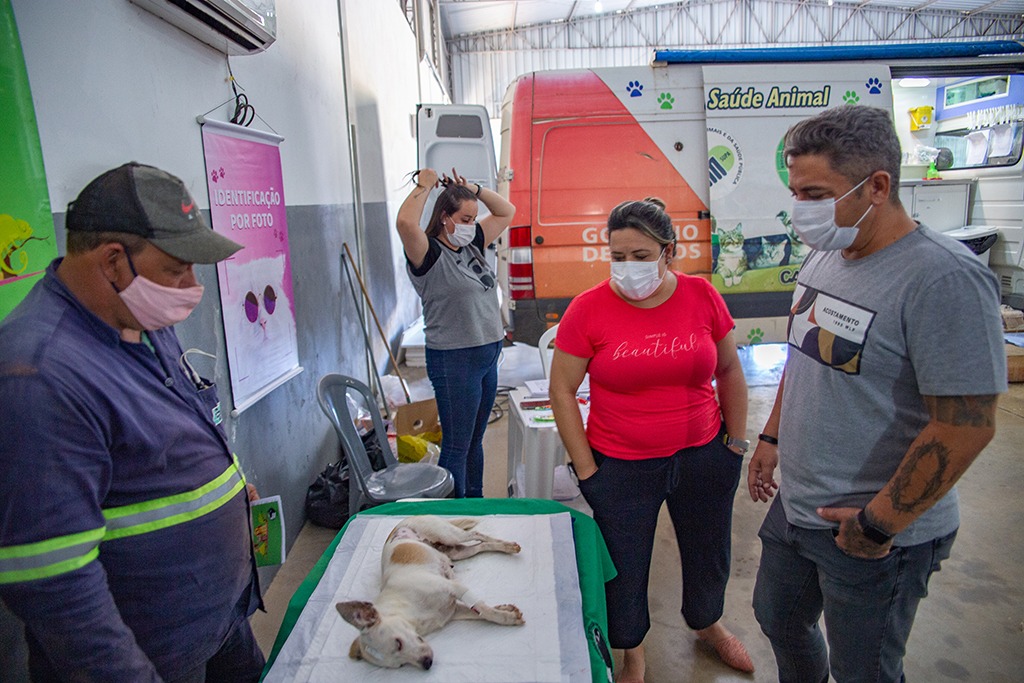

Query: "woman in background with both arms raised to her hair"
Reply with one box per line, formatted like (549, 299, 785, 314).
(397, 168, 515, 498)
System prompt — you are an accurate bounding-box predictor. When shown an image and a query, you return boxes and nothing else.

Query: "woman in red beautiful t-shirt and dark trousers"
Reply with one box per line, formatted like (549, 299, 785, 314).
(550, 199, 754, 683)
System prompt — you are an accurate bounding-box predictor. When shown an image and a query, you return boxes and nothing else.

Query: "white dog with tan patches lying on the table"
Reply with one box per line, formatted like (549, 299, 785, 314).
(336, 515, 524, 669)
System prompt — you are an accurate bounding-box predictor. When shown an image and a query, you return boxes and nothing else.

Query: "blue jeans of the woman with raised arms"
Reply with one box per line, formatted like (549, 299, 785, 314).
(426, 341, 502, 498)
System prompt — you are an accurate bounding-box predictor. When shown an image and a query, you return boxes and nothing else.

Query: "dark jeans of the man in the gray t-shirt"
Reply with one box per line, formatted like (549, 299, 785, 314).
(754, 497, 956, 683)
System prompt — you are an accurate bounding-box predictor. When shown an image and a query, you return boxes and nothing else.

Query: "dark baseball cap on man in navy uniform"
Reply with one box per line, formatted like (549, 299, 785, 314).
(66, 162, 242, 263)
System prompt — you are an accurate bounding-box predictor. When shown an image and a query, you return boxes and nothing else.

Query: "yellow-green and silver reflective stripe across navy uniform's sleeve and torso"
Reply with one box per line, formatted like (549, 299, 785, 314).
(0, 458, 245, 584)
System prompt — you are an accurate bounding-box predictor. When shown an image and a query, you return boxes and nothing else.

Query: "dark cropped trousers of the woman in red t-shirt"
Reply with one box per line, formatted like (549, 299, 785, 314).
(580, 432, 743, 648)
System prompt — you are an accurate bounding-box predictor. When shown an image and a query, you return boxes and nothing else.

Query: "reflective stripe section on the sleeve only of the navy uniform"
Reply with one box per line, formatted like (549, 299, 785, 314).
(0, 526, 106, 584)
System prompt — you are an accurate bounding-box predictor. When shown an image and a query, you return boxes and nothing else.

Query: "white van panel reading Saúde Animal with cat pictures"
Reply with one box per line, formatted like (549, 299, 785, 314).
(703, 62, 892, 294)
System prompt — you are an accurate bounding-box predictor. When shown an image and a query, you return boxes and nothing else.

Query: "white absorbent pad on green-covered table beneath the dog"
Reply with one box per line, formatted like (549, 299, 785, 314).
(264, 512, 591, 683)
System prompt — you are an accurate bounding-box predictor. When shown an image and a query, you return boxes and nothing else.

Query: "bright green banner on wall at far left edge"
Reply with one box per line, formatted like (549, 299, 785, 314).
(0, 0, 57, 321)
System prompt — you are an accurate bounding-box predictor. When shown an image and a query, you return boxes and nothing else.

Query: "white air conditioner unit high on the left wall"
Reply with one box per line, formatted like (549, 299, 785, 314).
(130, 0, 278, 54)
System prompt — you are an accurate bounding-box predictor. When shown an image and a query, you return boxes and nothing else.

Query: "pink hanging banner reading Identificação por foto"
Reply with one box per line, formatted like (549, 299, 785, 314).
(203, 121, 302, 416)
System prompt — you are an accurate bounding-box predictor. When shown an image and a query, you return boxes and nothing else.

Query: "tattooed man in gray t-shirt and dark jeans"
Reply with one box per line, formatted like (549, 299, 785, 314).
(748, 106, 1007, 682)
